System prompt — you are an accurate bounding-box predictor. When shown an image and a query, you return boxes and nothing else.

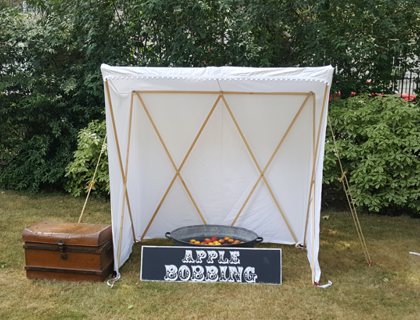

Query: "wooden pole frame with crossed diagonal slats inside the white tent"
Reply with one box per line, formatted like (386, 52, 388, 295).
(105, 80, 328, 281)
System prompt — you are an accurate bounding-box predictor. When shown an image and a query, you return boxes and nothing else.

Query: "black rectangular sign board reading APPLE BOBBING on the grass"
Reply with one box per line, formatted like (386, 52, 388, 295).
(140, 246, 281, 284)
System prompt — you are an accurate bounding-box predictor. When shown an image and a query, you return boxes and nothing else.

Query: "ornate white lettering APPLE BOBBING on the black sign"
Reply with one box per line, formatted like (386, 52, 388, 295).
(164, 250, 258, 283)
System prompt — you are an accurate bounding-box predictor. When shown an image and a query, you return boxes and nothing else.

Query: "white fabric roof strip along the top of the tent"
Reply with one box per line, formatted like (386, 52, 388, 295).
(101, 64, 333, 93)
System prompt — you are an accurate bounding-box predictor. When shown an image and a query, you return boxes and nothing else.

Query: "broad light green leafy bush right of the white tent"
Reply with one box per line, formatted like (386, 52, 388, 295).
(324, 95, 420, 214)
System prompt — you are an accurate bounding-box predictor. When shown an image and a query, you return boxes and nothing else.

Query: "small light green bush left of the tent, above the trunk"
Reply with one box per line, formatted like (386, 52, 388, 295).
(65, 120, 110, 197)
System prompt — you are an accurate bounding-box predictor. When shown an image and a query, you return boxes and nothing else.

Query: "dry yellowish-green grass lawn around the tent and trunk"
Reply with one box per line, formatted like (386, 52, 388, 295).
(0, 190, 420, 320)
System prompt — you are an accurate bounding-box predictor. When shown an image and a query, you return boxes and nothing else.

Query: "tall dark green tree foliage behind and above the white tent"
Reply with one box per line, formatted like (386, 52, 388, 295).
(0, 0, 420, 195)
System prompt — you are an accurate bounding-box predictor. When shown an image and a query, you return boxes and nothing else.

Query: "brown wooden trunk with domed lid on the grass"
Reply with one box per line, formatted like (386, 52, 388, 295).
(22, 221, 114, 281)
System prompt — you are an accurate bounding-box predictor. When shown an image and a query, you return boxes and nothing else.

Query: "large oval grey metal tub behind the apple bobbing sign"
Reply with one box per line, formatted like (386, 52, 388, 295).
(165, 224, 263, 247)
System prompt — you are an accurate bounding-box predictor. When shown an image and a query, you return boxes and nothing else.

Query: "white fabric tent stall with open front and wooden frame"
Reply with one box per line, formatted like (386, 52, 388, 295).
(101, 65, 333, 282)
